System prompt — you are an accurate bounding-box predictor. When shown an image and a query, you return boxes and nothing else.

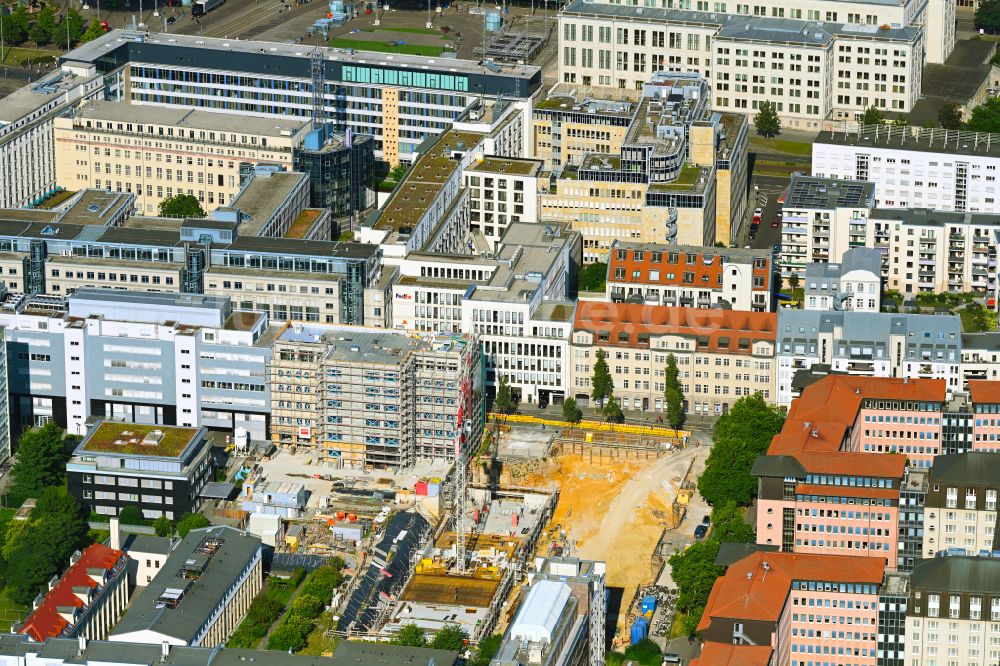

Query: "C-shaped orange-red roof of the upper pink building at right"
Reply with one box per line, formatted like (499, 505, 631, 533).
(767, 375, 947, 478)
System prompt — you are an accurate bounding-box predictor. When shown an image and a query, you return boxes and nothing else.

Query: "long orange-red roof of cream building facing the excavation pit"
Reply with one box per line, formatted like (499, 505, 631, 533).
(573, 301, 778, 354)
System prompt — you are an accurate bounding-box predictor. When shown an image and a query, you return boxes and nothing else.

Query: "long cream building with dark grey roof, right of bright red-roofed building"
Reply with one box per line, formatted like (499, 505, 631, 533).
(110, 526, 263, 651)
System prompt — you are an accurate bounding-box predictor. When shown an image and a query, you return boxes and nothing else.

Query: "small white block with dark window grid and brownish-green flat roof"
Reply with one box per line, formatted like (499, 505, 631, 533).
(465, 157, 542, 248)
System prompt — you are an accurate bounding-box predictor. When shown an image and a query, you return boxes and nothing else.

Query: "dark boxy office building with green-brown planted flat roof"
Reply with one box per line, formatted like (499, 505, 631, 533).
(66, 421, 214, 520)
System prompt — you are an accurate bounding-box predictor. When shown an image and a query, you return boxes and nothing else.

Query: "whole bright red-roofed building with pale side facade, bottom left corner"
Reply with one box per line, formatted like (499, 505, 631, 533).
(12, 543, 129, 643)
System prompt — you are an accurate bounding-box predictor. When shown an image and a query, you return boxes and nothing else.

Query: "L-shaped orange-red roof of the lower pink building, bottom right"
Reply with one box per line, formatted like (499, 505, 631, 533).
(698, 552, 885, 631)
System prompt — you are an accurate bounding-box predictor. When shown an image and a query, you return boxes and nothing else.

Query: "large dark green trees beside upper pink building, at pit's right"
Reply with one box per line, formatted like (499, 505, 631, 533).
(698, 393, 785, 506)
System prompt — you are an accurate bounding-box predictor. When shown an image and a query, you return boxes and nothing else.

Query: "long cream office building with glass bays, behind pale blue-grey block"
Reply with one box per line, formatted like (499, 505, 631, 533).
(0, 191, 381, 324)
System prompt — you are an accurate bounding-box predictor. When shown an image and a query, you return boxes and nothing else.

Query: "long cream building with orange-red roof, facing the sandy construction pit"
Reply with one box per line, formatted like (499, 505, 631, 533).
(570, 301, 777, 415)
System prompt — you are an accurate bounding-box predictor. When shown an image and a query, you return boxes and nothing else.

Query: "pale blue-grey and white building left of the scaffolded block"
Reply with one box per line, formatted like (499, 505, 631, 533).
(0, 288, 271, 439)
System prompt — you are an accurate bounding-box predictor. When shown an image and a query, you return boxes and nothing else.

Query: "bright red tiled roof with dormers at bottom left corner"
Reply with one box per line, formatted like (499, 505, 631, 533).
(18, 543, 125, 643)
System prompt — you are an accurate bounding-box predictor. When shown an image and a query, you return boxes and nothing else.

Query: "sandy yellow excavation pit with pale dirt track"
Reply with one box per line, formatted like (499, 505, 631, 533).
(486, 426, 709, 644)
